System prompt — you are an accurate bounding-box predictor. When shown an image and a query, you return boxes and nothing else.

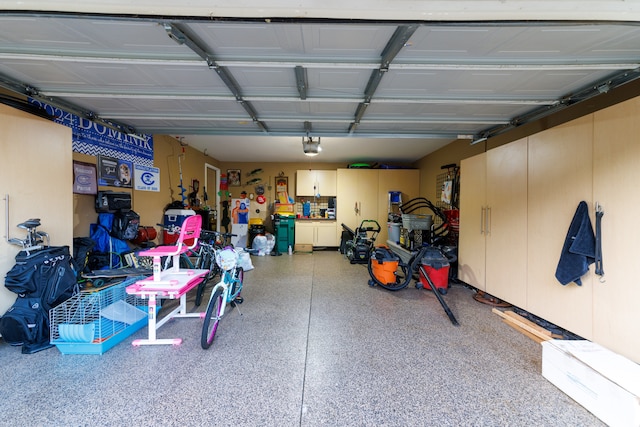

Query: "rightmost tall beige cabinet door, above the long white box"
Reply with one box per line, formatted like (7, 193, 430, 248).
(593, 98, 640, 363)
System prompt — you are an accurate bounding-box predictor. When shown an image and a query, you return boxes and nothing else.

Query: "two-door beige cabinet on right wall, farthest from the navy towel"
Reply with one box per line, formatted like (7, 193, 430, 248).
(458, 139, 527, 307)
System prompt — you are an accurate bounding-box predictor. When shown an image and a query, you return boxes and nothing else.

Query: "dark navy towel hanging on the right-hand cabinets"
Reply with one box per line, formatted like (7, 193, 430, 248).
(556, 201, 596, 286)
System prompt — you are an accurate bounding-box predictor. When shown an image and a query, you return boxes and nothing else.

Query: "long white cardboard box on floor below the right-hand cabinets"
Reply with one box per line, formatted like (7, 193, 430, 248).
(542, 340, 640, 426)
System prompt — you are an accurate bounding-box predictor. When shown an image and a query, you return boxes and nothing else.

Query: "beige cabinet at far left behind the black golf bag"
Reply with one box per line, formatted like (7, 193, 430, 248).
(0, 105, 74, 315)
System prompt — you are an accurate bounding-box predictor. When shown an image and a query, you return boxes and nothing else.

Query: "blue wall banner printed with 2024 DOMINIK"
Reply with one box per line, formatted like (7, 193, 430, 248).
(29, 98, 153, 166)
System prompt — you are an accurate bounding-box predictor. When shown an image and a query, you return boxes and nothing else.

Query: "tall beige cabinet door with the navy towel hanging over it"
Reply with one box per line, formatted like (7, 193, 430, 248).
(523, 115, 596, 339)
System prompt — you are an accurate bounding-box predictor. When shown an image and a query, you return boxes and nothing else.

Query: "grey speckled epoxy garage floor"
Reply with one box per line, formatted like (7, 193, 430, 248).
(0, 251, 603, 426)
